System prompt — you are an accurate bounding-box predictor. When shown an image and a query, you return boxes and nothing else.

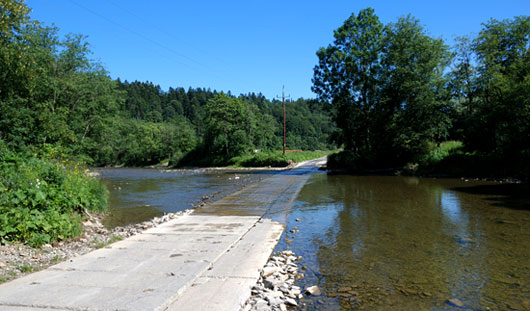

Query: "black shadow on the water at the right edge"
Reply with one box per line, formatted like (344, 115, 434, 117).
(451, 184, 530, 211)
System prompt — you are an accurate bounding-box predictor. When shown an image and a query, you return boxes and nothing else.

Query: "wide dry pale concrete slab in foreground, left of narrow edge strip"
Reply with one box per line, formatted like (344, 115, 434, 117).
(0, 215, 259, 310)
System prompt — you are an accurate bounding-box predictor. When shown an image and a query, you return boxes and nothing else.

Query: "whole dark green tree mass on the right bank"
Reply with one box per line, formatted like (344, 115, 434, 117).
(313, 8, 530, 178)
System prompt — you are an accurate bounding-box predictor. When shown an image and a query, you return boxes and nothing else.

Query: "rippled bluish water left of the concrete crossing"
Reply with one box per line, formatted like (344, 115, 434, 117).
(95, 168, 265, 228)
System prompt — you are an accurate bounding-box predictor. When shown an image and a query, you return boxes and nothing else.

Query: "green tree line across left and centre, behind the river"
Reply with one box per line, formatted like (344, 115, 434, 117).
(0, 0, 333, 166)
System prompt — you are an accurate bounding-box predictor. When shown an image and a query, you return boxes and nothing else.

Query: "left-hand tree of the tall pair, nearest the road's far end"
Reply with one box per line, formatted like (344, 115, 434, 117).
(312, 8, 383, 154)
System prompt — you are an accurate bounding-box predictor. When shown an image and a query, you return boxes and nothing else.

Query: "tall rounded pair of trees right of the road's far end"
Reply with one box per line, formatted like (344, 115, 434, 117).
(313, 8, 450, 166)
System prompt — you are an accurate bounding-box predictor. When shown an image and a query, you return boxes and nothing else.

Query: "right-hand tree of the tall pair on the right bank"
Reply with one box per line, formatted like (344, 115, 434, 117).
(376, 15, 451, 163)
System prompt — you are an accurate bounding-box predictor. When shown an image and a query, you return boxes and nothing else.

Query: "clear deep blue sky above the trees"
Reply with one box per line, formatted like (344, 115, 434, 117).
(26, 0, 530, 98)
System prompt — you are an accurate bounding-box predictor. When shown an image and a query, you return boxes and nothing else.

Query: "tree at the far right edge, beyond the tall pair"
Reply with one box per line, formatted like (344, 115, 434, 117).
(465, 16, 530, 158)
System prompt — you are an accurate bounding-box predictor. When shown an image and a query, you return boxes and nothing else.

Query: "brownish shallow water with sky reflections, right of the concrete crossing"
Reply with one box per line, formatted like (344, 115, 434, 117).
(279, 175, 530, 310)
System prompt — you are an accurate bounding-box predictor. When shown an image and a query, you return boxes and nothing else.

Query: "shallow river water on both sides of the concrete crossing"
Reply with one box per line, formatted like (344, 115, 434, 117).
(100, 169, 530, 310)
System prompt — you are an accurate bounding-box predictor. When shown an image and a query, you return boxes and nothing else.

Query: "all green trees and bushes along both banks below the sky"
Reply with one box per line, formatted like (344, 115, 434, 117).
(0, 0, 530, 246)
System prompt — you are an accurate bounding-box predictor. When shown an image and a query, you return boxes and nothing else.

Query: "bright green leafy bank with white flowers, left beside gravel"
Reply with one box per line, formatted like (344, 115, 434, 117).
(0, 140, 108, 246)
